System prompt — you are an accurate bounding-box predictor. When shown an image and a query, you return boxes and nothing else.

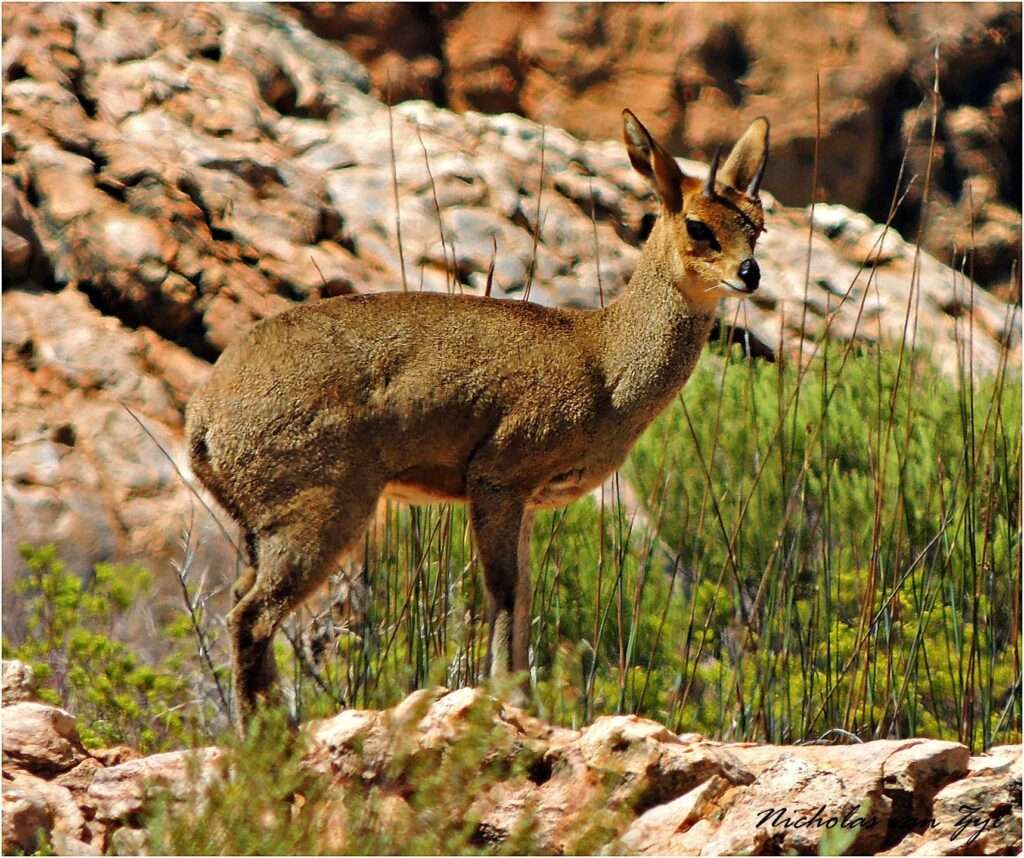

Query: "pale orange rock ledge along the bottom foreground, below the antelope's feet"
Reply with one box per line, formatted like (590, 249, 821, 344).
(3, 663, 1024, 855)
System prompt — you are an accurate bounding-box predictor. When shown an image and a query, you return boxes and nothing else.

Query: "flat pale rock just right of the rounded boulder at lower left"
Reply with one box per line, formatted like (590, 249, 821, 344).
(87, 747, 224, 823)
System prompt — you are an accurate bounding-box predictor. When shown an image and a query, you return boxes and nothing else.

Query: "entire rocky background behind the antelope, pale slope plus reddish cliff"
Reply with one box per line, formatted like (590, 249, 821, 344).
(2, 3, 1021, 597)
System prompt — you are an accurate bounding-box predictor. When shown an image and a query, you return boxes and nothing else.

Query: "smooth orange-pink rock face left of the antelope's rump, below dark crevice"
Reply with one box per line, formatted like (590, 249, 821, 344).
(3, 290, 233, 597)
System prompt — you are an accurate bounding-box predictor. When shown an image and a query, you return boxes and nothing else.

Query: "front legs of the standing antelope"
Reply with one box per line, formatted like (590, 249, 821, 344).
(470, 487, 532, 690)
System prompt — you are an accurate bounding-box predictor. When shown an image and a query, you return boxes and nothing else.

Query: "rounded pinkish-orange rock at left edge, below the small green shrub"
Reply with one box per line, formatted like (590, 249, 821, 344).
(3, 702, 86, 775)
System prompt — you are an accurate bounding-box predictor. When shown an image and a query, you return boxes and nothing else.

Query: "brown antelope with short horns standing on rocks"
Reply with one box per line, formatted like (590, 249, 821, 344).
(186, 110, 768, 724)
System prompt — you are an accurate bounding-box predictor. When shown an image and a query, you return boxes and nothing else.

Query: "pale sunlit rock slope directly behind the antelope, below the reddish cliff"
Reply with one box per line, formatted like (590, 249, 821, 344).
(3, 4, 1020, 589)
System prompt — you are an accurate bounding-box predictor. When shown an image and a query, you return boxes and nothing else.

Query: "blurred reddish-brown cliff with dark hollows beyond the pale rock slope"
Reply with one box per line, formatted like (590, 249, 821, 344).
(294, 3, 1021, 296)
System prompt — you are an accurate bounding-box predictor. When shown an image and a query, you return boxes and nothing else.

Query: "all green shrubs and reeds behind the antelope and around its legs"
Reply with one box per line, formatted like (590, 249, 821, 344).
(5, 346, 1021, 750)
